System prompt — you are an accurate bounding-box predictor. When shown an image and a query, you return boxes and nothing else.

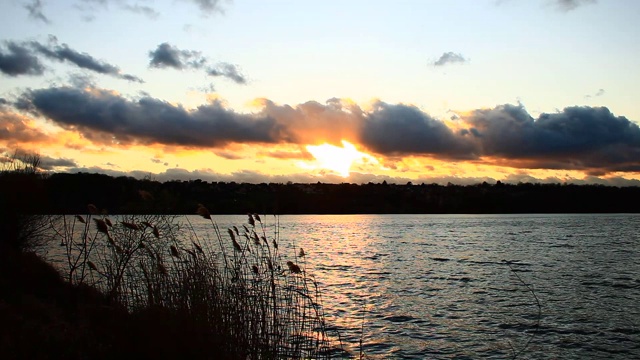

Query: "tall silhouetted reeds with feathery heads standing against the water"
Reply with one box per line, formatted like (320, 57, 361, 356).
(51, 206, 334, 359)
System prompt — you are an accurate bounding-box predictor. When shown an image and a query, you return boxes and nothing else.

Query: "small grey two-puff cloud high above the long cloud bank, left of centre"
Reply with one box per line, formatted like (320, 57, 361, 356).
(149, 43, 247, 84)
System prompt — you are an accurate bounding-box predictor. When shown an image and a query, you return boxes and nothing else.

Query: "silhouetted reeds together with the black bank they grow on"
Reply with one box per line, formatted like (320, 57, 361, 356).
(0, 155, 339, 359)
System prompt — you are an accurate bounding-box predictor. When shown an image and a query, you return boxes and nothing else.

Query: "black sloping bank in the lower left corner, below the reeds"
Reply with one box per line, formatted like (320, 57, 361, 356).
(0, 248, 255, 359)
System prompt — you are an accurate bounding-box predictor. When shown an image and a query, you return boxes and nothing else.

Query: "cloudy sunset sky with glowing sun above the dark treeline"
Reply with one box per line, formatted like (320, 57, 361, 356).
(0, 0, 640, 186)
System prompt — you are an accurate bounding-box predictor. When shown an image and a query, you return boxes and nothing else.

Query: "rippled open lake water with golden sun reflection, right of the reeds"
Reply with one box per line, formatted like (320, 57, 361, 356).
(190, 214, 640, 359)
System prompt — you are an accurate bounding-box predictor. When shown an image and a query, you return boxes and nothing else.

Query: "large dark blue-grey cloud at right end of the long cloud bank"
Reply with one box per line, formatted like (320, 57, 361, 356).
(464, 105, 640, 172)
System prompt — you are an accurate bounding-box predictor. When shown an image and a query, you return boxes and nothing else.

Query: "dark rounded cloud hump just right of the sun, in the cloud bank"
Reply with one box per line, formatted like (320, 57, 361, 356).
(361, 102, 474, 158)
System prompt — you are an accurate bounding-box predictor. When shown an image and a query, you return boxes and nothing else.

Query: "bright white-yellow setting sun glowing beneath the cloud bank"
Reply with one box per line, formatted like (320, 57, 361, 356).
(302, 140, 375, 178)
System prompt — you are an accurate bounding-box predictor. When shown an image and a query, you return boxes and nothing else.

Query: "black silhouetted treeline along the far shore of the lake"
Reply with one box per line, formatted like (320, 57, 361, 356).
(27, 173, 640, 214)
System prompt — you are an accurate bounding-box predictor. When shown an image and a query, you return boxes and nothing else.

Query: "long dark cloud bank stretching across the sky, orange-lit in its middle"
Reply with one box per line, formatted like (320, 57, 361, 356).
(14, 83, 640, 175)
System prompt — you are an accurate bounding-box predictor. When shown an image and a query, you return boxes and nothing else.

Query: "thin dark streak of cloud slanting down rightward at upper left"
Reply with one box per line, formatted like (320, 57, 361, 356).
(30, 41, 143, 83)
